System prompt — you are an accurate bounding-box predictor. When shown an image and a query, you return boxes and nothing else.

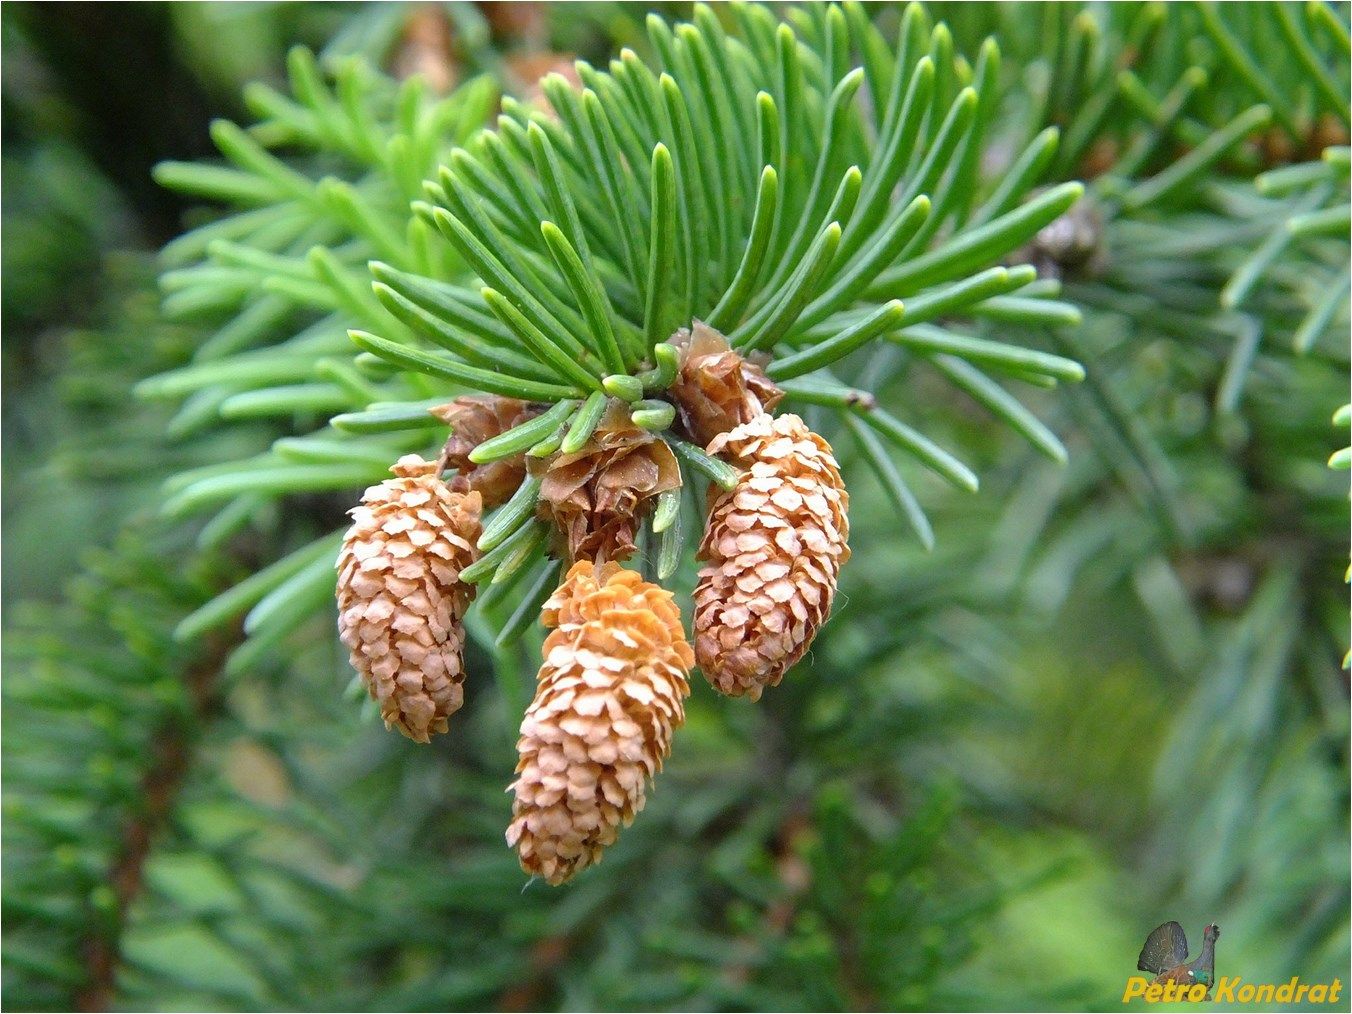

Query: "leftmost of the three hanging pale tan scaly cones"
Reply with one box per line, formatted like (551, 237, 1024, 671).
(338, 454, 483, 742)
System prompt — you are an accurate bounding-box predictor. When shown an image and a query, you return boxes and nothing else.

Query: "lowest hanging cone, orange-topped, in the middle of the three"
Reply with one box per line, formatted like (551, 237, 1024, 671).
(507, 561, 694, 884)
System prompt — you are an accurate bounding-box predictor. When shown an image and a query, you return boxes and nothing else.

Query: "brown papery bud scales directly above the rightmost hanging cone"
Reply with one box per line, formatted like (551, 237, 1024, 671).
(671, 320, 784, 446)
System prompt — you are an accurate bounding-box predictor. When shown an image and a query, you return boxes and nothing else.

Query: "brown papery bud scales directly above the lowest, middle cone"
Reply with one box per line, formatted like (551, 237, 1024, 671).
(530, 402, 680, 561)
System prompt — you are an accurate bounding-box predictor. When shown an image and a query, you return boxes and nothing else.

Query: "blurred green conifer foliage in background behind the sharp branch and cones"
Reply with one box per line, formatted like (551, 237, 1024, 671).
(3, 4, 1349, 1010)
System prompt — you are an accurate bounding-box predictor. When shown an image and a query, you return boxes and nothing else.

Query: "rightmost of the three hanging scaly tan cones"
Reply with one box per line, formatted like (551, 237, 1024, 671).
(695, 415, 849, 700)
